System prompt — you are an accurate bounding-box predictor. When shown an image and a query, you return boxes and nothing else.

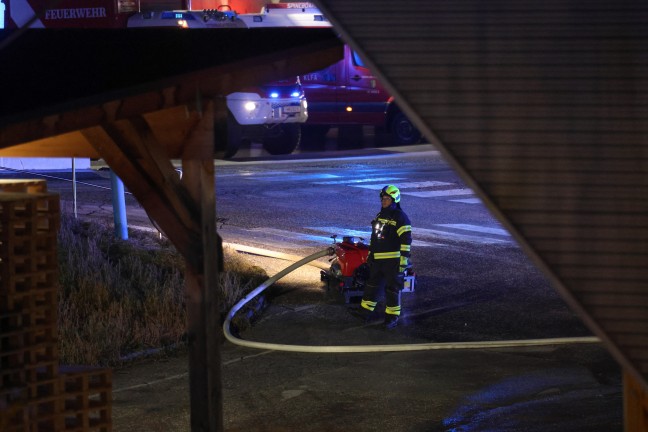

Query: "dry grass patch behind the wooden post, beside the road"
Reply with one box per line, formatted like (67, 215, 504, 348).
(58, 214, 268, 366)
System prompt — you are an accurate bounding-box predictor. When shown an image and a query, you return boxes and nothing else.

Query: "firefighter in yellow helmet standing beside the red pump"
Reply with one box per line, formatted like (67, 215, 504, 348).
(351, 185, 412, 330)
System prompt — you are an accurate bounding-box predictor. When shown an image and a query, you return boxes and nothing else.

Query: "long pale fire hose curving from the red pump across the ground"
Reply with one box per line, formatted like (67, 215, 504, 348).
(223, 244, 601, 353)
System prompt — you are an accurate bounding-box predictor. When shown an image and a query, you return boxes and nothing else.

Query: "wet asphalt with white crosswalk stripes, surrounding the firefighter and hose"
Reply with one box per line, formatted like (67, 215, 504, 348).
(2, 146, 622, 432)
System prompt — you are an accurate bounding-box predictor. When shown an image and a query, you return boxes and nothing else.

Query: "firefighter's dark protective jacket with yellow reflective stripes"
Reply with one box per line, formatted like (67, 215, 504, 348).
(369, 204, 412, 262)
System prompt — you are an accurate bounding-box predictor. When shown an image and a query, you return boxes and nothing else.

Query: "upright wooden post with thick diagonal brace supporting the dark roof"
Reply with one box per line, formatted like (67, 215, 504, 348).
(84, 118, 223, 432)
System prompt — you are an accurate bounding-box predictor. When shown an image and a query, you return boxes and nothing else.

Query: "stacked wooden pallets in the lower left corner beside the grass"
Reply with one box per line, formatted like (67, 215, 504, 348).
(0, 180, 112, 432)
